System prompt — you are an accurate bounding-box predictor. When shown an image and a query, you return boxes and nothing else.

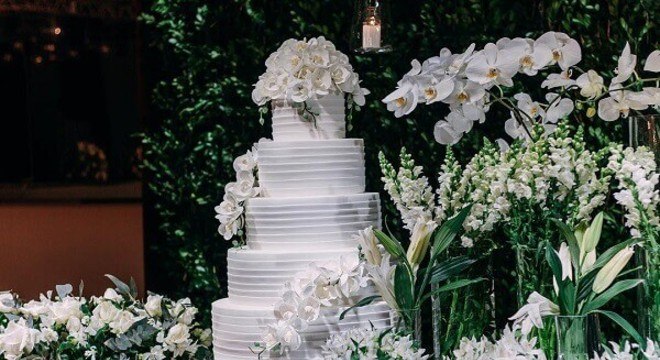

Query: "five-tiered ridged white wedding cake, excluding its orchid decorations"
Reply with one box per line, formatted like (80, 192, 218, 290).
(213, 95, 391, 360)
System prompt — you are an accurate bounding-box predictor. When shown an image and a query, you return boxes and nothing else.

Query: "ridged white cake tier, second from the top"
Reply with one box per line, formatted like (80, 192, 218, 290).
(259, 139, 365, 197)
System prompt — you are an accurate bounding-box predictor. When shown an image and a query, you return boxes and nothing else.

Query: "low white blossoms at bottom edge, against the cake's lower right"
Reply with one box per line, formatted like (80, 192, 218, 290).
(323, 329, 429, 360)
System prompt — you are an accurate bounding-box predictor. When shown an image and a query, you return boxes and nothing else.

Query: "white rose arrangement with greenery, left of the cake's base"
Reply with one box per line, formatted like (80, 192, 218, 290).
(0, 276, 213, 360)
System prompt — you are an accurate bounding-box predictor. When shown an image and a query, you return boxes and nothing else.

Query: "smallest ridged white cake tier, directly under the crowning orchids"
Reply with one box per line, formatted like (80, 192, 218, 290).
(273, 94, 346, 141)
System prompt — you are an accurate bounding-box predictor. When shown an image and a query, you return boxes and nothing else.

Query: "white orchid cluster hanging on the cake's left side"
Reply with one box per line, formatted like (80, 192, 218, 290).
(215, 146, 261, 240)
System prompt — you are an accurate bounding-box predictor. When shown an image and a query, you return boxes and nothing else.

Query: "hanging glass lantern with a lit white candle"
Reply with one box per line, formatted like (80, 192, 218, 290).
(351, 0, 392, 54)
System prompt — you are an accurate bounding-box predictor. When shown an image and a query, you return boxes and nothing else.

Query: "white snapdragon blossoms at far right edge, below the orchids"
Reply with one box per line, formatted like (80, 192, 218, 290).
(608, 146, 660, 238)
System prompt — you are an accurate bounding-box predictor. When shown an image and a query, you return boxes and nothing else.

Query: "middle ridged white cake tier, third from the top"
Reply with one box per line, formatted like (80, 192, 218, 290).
(245, 193, 381, 252)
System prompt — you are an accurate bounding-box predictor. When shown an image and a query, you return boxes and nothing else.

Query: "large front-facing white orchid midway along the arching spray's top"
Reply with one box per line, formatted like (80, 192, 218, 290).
(465, 43, 519, 88)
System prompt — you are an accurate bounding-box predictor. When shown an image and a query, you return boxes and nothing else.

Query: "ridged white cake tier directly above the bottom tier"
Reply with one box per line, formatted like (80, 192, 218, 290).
(227, 246, 376, 309)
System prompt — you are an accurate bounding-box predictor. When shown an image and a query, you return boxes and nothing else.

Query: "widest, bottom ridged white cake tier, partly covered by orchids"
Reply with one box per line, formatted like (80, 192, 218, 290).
(212, 299, 392, 360)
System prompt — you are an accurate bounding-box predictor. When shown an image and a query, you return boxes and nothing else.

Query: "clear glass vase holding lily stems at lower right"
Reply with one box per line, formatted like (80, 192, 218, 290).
(555, 314, 600, 360)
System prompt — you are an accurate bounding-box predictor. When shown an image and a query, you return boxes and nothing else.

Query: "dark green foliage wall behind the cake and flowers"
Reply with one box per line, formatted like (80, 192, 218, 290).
(143, 0, 660, 324)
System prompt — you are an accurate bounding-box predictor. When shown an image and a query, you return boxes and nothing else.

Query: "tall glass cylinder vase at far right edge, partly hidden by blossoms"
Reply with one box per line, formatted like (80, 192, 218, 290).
(628, 114, 660, 337)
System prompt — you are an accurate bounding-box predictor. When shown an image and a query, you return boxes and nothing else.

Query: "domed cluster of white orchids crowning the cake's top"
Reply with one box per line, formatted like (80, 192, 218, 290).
(252, 36, 369, 106)
